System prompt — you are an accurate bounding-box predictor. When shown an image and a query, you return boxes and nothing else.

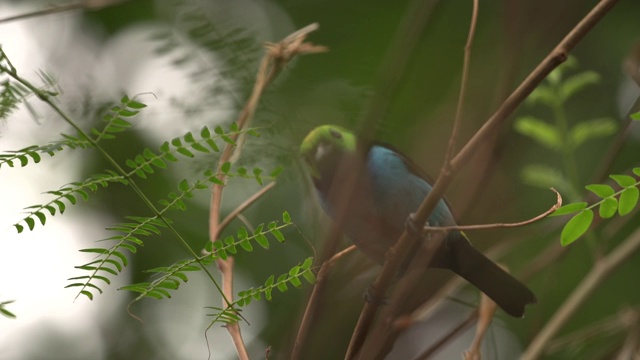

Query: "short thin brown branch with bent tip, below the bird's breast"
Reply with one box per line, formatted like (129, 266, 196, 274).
(291, 245, 356, 360)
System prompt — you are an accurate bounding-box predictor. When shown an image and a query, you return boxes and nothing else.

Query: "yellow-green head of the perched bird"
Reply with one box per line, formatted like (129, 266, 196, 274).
(300, 125, 356, 180)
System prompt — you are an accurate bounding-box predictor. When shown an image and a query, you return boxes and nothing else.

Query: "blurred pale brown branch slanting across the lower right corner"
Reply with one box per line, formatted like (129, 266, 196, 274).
(521, 224, 640, 360)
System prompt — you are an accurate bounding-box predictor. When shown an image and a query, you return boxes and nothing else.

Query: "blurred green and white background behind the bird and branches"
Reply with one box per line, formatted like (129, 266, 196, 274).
(0, 0, 640, 359)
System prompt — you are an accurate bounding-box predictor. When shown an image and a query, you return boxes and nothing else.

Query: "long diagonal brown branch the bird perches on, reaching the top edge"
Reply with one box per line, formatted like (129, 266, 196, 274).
(347, 0, 617, 358)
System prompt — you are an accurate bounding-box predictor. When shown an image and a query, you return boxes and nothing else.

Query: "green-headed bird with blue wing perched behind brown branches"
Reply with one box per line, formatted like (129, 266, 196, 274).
(300, 125, 537, 318)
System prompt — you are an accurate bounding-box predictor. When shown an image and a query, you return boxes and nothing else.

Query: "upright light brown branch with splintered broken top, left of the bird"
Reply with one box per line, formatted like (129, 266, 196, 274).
(209, 24, 327, 359)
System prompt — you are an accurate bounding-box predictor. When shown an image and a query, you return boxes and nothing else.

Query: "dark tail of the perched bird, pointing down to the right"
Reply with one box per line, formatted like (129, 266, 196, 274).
(447, 234, 537, 317)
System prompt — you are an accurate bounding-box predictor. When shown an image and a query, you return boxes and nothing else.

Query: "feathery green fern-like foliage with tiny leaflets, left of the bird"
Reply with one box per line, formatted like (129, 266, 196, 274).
(0, 45, 314, 332)
